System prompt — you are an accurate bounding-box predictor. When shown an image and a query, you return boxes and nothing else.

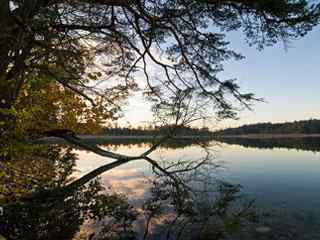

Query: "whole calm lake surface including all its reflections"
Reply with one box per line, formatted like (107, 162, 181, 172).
(0, 138, 320, 240)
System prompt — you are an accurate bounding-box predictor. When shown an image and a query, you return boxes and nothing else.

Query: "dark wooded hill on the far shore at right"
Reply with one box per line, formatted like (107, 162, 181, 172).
(215, 119, 320, 135)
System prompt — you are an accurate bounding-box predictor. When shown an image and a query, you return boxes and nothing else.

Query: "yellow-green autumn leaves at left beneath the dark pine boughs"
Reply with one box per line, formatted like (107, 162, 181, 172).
(16, 78, 125, 134)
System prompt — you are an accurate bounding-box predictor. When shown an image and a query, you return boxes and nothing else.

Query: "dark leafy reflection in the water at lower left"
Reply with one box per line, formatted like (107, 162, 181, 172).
(0, 145, 139, 240)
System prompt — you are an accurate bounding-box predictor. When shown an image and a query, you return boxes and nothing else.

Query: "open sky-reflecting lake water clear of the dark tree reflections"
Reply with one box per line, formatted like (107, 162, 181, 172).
(76, 138, 320, 239)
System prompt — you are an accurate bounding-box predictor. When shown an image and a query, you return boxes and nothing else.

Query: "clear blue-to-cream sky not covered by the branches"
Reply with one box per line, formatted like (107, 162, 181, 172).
(121, 27, 320, 129)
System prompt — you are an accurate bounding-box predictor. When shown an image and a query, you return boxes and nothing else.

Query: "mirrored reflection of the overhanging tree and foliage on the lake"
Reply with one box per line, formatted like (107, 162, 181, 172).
(0, 141, 260, 240)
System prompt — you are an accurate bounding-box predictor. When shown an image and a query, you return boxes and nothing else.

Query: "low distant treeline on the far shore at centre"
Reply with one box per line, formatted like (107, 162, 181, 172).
(103, 126, 212, 136)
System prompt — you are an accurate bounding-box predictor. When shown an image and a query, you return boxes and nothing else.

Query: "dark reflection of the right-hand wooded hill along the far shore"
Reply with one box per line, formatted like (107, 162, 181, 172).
(217, 137, 320, 152)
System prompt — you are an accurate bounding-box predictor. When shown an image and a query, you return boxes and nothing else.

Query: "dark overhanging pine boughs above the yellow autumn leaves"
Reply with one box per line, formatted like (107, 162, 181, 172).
(0, 0, 319, 126)
